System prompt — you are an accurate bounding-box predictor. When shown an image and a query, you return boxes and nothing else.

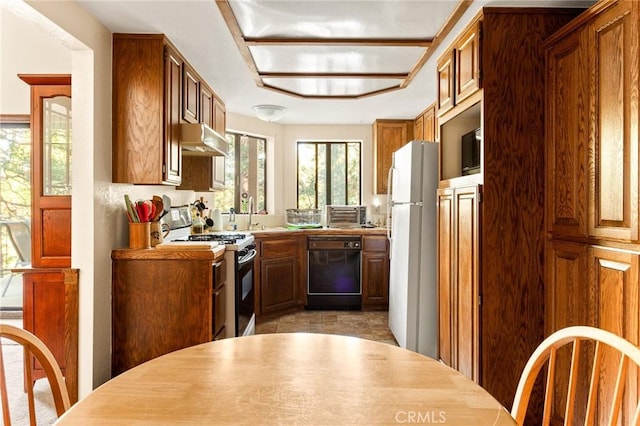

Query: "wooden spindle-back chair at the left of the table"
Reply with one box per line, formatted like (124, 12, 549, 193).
(0, 324, 71, 426)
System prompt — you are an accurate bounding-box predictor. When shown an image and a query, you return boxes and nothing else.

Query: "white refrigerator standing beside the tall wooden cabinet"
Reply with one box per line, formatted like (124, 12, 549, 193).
(387, 141, 438, 358)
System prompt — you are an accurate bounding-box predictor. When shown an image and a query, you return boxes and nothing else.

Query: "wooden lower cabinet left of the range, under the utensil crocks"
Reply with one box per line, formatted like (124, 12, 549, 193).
(111, 250, 227, 376)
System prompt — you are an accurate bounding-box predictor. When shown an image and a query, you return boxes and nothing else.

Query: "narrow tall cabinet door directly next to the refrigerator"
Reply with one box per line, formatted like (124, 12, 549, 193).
(438, 189, 456, 368)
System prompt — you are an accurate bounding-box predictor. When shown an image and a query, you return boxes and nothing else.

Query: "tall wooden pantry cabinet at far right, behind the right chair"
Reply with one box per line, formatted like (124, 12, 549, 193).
(545, 1, 640, 424)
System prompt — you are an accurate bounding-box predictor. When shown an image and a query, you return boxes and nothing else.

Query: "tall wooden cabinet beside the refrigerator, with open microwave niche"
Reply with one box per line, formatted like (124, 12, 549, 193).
(437, 8, 579, 407)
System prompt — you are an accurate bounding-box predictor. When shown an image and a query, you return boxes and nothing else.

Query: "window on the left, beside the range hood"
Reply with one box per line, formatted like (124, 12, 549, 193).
(213, 132, 267, 213)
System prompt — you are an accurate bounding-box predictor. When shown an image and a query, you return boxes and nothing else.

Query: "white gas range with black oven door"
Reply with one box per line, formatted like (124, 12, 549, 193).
(166, 206, 257, 337)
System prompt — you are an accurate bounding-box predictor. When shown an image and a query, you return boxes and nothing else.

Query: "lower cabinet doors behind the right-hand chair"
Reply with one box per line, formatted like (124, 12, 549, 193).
(545, 240, 640, 424)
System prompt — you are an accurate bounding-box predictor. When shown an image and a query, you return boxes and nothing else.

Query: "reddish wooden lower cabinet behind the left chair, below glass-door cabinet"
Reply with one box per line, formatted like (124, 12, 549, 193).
(22, 269, 78, 403)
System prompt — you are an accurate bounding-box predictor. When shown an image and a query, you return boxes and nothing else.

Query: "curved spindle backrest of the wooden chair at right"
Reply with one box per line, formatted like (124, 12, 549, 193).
(511, 326, 640, 425)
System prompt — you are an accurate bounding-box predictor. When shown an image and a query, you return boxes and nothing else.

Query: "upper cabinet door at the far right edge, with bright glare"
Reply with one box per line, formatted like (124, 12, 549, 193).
(588, 1, 640, 241)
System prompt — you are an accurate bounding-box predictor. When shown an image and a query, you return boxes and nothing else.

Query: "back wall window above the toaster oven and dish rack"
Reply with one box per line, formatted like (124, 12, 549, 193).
(297, 141, 362, 209)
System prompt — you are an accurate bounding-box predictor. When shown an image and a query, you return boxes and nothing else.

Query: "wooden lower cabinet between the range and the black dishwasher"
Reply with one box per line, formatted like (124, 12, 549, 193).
(255, 235, 306, 317)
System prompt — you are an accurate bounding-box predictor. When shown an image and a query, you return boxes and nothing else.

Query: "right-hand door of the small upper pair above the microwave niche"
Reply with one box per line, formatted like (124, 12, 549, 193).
(454, 22, 481, 104)
